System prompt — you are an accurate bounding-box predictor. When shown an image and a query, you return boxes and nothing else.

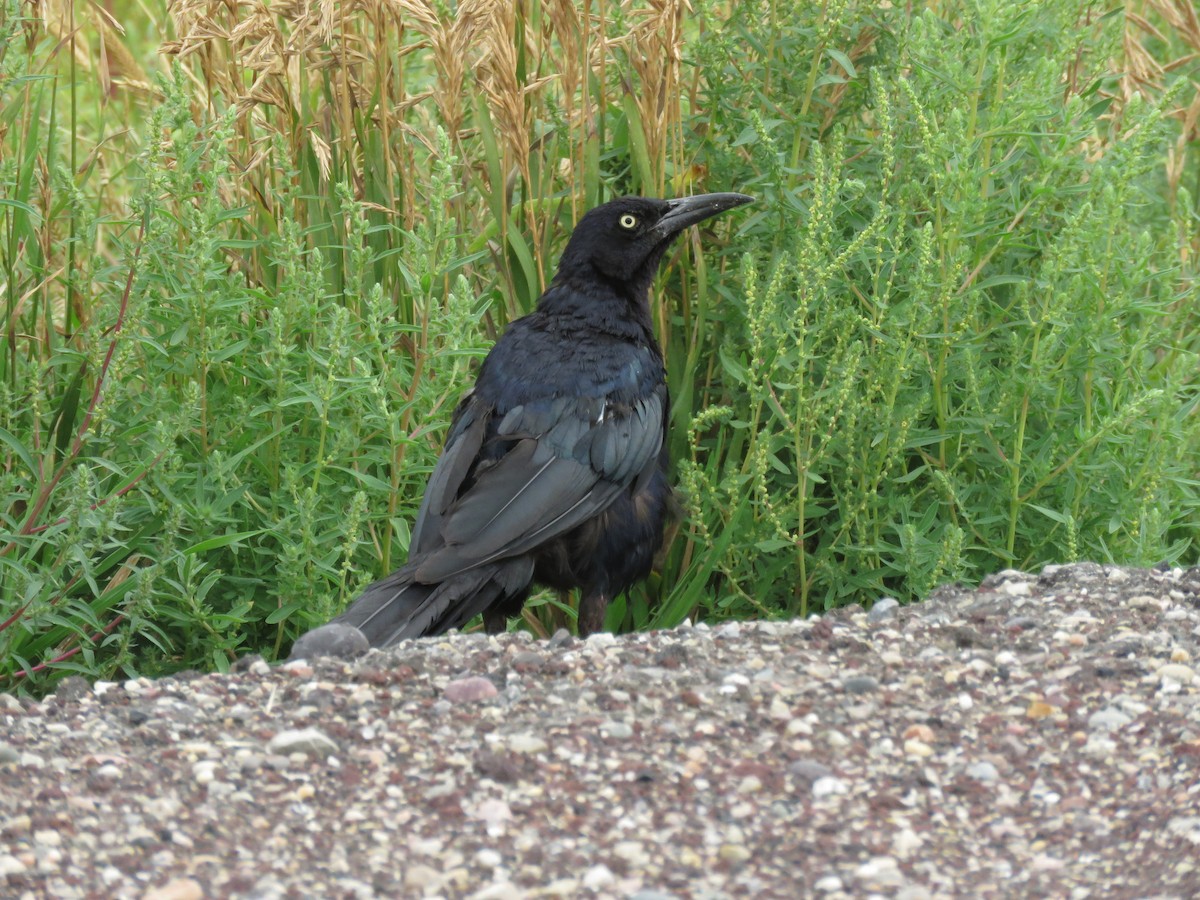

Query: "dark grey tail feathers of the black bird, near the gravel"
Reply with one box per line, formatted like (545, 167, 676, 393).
(334, 565, 504, 647)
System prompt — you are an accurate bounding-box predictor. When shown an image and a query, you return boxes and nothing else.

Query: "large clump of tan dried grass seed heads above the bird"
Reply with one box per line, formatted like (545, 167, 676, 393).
(163, 0, 667, 278)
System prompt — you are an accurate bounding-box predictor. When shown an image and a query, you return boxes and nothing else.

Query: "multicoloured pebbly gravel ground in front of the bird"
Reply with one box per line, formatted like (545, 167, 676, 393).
(0, 564, 1200, 900)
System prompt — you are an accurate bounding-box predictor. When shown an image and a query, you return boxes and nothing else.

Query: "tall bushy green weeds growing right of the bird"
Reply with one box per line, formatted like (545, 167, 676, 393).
(683, 5, 1200, 614)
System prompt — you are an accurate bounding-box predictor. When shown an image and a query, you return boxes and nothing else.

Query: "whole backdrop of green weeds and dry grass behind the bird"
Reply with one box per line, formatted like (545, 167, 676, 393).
(0, 0, 1200, 689)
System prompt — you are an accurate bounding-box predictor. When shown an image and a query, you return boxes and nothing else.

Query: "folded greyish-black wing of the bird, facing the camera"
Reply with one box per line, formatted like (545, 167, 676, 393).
(416, 386, 666, 583)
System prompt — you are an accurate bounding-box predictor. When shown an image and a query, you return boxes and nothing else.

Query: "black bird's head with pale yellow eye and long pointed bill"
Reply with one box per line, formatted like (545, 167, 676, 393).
(558, 193, 754, 300)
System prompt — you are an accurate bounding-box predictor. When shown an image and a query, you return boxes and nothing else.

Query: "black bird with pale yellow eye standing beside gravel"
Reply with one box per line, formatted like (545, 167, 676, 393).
(292, 193, 752, 656)
